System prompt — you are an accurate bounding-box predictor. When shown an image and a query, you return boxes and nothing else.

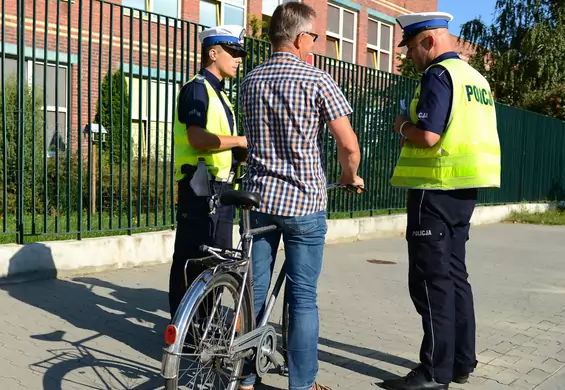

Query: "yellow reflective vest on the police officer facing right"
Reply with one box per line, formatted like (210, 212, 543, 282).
(174, 75, 236, 181)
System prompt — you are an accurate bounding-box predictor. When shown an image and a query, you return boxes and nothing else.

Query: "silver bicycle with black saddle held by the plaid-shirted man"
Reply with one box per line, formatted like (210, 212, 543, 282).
(161, 184, 365, 390)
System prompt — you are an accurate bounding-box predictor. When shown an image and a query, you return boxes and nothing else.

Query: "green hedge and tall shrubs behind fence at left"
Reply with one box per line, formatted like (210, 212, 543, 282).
(0, 72, 171, 218)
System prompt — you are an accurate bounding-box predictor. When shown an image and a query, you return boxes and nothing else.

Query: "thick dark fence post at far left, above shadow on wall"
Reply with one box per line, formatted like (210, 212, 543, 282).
(15, 0, 27, 244)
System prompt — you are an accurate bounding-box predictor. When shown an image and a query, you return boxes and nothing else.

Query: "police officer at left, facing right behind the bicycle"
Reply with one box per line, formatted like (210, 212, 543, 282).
(169, 26, 247, 319)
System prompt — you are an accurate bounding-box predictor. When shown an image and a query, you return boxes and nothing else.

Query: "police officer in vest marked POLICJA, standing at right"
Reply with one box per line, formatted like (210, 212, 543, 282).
(382, 12, 500, 390)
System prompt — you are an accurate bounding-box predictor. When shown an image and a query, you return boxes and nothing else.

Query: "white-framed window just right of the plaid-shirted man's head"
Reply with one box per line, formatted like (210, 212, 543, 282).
(326, 4, 357, 63)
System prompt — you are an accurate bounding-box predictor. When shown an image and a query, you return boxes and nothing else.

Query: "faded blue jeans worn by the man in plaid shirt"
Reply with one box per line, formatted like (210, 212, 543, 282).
(241, 211, 327, 390)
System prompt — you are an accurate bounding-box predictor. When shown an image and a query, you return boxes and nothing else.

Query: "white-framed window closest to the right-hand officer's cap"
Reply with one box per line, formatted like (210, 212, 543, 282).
(367, 19, 393, 72)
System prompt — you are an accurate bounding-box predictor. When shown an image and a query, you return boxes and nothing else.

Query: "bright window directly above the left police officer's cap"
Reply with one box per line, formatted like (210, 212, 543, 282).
(199, 0, 246, 27)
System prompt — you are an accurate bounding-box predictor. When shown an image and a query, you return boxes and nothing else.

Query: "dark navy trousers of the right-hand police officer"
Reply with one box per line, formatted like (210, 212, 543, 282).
(406, 189, 477, 383)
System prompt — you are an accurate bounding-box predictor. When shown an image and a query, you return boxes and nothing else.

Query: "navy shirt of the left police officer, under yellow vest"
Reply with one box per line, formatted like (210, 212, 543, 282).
(177, 69, 236, 135)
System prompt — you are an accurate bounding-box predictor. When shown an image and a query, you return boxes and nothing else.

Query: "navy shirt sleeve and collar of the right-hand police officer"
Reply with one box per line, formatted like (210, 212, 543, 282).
(416, 51, 460, 135)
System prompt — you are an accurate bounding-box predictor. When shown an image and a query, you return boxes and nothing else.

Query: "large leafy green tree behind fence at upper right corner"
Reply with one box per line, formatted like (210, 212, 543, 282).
(460, 0, 565, 108)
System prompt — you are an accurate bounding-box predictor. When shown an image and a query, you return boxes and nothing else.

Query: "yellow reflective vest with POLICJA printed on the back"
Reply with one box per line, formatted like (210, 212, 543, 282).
(391, 59, 501, 190)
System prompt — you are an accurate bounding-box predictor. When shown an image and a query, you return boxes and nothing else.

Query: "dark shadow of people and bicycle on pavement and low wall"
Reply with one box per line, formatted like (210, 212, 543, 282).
(0, 243, 169, 390)
